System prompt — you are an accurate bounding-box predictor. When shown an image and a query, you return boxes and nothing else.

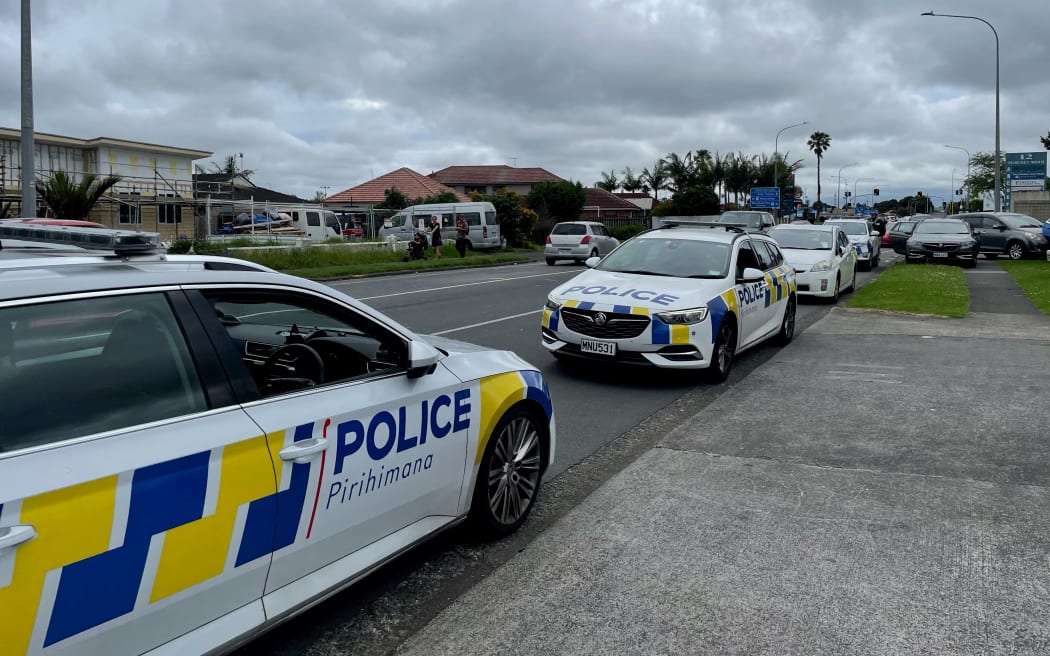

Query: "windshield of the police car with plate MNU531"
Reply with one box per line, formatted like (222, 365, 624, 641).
(596, 238, 730, 278)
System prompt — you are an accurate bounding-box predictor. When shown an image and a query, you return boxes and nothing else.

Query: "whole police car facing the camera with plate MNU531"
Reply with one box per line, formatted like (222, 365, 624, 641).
(541, 219, 796, 381)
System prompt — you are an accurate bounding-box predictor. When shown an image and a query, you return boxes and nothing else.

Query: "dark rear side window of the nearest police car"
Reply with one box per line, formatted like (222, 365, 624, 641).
(0, 294, 208, 451)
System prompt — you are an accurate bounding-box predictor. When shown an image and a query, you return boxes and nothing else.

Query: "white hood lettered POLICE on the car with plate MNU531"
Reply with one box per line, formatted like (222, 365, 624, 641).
(550, 270, 734, 313)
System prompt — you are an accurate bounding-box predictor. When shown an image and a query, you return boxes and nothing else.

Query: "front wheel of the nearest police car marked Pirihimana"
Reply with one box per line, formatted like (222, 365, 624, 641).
(469, 405, 547, 538)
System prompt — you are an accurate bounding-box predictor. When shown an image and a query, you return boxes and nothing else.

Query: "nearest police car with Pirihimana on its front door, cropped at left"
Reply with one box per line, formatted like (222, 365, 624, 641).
(0, 221, 555, 655)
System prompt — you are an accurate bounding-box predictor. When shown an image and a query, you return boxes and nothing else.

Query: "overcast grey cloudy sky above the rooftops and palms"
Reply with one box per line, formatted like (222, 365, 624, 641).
(0, 0, 1050, 202)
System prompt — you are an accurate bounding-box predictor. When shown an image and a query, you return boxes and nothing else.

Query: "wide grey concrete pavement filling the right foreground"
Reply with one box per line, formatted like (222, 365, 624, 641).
(398, 308, 1050, 656)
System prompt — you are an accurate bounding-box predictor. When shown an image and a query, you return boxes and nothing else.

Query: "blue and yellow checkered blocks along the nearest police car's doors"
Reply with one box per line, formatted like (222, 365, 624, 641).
(0, 424, 314, 654)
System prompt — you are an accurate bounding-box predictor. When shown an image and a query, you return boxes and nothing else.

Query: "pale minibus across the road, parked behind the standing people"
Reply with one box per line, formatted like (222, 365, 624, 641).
(379, 203, 503, 251)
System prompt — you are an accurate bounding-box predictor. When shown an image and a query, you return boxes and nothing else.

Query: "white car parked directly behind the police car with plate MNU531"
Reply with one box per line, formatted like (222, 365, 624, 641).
(768, 224, 857, 303)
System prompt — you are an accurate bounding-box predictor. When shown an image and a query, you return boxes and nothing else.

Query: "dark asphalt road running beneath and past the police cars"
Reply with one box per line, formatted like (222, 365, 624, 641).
(240, 253, 894, 656)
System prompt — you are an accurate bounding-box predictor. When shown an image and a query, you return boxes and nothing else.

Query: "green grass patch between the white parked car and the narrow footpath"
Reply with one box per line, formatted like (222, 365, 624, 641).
(845, 263, 970, 318)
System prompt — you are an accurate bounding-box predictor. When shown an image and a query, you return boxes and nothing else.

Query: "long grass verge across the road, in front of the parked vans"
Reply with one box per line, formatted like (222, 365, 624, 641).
(239, 246, 528, 278)
